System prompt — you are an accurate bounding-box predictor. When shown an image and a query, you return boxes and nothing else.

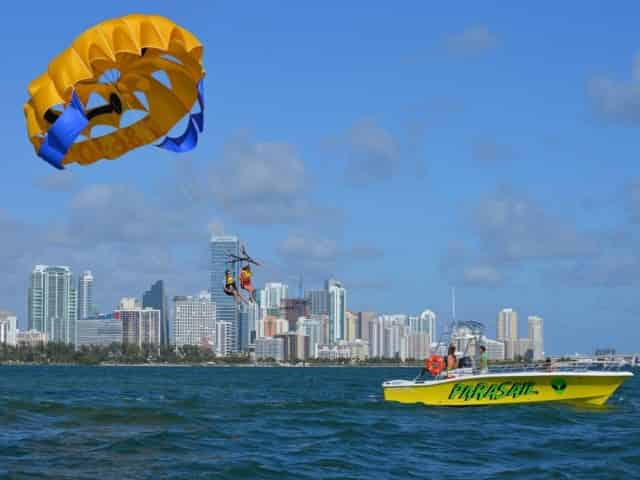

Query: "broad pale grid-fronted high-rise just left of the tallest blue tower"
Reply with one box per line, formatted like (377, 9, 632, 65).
(173, 292, 216, 347)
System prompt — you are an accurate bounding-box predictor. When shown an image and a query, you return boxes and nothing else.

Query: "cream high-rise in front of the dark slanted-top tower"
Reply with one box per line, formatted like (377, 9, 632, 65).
(113, 298, 160, 347)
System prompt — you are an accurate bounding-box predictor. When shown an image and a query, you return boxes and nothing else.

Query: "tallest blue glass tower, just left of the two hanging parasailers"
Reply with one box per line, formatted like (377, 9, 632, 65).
(209, 236, 240, 353)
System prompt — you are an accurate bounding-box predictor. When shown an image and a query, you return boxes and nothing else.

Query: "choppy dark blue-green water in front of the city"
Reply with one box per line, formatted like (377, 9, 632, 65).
(0, 366, 640, 480)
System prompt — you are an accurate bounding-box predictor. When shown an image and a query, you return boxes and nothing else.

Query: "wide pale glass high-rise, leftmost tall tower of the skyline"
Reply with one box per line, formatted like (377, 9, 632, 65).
(28, 265, 77, 344)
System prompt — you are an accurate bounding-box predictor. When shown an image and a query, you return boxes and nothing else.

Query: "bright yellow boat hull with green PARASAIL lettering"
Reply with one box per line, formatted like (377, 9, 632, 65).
(382, 372, 633, 406)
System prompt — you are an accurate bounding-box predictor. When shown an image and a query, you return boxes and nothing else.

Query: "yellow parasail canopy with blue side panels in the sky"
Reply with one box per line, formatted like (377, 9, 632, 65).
(24, 14, 205, 168)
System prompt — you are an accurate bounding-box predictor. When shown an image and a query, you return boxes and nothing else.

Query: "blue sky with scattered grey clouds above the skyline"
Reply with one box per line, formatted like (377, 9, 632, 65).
(0, 1, 640, 352)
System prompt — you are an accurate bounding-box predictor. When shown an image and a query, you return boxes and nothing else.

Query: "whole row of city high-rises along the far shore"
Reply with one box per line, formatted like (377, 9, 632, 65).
(0, 248, 545, 362)
